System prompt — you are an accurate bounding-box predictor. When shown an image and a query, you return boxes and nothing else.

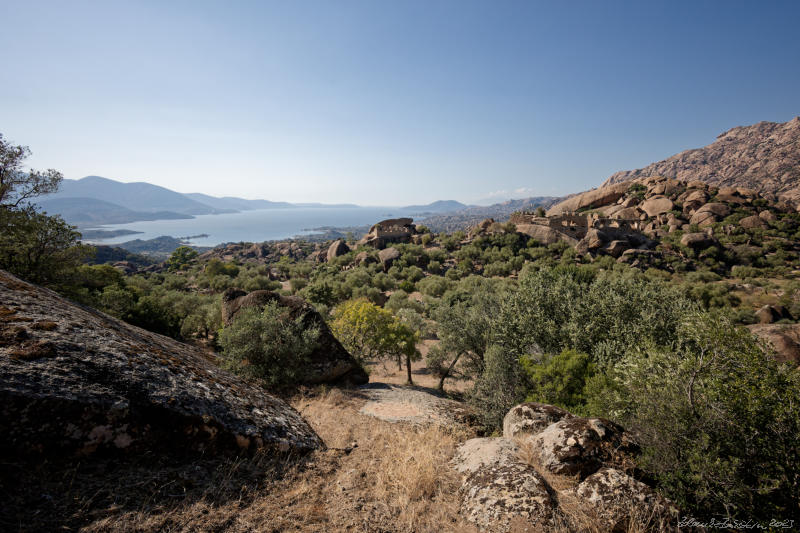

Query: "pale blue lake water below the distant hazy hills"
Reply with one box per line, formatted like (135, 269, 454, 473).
(87, 207, 422, 246)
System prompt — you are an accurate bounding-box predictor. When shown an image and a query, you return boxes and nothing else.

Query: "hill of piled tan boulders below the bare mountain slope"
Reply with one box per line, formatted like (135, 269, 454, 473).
(511, 176, 796, 268)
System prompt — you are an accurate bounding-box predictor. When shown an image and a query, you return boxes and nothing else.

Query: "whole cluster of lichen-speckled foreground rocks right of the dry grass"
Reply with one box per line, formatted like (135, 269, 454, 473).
(453, 403, 677, 532)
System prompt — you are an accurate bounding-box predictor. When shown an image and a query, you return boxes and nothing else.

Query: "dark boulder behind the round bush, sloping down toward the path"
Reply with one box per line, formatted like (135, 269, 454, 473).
(222, 289, 369, 385)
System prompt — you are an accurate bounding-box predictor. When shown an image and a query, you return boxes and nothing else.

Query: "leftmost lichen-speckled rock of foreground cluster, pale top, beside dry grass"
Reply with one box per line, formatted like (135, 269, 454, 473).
(453, 438, 554, 532)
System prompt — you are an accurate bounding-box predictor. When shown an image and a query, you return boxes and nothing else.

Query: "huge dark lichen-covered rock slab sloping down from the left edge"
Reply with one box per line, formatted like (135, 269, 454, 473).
(0, 271, 323, 456)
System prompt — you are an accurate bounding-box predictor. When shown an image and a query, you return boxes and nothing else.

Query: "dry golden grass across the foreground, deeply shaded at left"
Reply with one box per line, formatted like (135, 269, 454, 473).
(6, 389, 476, 533)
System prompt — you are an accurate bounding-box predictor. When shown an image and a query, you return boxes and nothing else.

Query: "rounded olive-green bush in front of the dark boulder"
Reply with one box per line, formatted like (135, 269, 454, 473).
(219, 302, 320, 387)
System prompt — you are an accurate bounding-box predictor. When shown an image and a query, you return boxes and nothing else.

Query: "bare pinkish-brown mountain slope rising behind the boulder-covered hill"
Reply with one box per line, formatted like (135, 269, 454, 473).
(603, 117, 800, 203)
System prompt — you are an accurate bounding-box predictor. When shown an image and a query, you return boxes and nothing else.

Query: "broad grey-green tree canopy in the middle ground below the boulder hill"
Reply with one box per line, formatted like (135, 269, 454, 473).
(497, 266, 691, 366)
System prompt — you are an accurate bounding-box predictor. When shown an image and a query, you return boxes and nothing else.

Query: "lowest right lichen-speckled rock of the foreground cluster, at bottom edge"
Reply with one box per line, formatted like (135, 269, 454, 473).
(574, 468, 678, 533)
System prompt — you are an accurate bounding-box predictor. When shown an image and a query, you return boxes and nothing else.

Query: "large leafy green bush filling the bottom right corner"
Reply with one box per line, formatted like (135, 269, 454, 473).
(594, 314, 800, 520)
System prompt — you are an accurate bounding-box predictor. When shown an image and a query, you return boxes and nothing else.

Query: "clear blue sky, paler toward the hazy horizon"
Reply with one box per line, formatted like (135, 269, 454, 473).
(0, 0, 800, 205)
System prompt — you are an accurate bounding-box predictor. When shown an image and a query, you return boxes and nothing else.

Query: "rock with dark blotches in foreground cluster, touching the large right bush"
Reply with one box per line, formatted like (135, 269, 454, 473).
(526, 418, 639, 479)
